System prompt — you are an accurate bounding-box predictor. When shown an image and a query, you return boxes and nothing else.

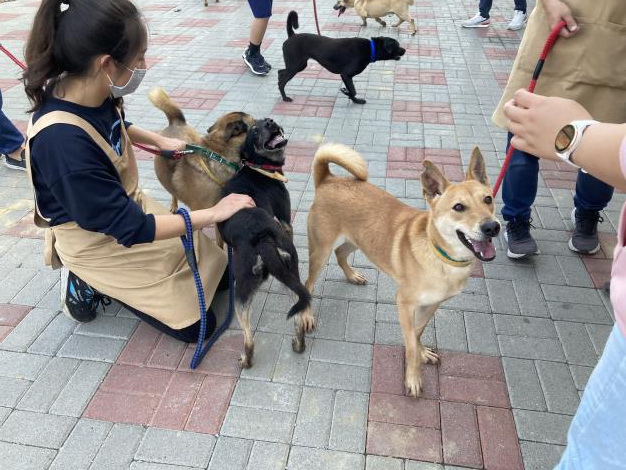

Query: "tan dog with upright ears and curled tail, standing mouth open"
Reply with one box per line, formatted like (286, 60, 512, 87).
(297, 144, 500, 397)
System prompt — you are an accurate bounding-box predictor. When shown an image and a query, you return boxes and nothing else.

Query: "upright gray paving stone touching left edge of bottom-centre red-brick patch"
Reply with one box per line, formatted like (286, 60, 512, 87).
(329, 390, 369, 453)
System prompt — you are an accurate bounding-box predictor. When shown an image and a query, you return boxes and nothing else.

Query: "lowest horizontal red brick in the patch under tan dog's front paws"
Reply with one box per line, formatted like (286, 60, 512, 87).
(366, 421, 442, 463)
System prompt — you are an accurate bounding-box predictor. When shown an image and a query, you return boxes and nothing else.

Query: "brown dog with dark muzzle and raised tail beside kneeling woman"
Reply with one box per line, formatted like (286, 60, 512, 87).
(149, 88, 255, 212)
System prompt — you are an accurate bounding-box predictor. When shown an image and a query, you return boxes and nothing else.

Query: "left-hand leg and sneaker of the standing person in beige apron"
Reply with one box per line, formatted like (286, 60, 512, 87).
(502, 133, 539, 258)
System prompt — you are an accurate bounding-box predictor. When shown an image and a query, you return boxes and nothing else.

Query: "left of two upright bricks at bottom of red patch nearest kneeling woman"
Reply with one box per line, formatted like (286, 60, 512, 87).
(150, 372, 204, 430)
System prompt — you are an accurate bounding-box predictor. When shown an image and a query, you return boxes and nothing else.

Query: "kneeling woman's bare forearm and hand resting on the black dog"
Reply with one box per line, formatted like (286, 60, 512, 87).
(154, 194, 255, 240)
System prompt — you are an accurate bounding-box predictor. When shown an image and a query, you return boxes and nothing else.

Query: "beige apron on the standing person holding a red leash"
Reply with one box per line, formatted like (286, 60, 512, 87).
(492, 0, 626, 127)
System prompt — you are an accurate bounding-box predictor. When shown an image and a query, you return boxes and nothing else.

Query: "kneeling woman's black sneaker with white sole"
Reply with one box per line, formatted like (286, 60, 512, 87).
(61, 271, 111, 323)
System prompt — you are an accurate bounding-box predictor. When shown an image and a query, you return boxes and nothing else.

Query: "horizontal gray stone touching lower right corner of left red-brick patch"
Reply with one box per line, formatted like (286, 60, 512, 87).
(221, 406, 296, 444)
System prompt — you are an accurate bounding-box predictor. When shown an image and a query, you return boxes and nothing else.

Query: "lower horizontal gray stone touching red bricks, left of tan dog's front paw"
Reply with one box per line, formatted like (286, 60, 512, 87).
(305, 361, 370, 392)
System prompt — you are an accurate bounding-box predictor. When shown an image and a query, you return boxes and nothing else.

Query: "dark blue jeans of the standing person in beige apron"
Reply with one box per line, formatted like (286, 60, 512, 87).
(502, 133, 613, 221)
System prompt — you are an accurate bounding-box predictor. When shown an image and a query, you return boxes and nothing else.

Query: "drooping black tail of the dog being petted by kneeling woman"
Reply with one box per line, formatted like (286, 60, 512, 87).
(257, 236, 311, 318)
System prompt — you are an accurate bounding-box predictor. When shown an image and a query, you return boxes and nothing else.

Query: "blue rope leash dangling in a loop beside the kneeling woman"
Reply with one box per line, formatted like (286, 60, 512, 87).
(176, 207, 235, 369)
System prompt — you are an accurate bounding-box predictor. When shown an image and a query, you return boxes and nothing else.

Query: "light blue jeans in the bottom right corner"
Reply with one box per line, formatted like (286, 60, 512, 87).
(555, 326, 626, 470)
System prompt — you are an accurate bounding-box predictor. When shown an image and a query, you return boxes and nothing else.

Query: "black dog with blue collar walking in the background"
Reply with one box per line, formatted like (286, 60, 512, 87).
(278, 11, 406, 104)
